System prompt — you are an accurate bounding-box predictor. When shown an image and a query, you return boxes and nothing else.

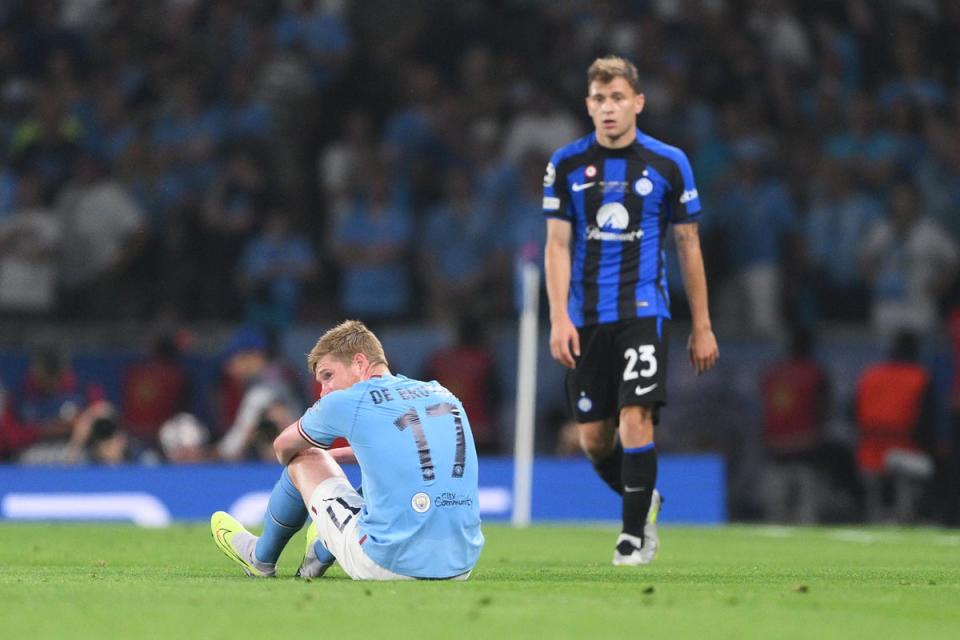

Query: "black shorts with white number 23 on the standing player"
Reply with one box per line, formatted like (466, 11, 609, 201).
(567, 318, 669, 422)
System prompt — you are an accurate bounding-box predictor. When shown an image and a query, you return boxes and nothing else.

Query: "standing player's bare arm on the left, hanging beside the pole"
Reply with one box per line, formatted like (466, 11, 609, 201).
(543, 218, 580, 369)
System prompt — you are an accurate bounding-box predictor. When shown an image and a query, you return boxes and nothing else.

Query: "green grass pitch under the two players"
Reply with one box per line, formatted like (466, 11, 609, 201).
(0, 524, 960, 640)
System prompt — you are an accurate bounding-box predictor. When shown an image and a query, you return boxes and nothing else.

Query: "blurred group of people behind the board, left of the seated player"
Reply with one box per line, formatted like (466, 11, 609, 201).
(0, 327, 296, 465)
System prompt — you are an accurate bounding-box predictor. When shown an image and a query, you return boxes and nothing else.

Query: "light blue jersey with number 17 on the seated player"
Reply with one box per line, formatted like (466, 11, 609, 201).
(300, 374, 483, 578)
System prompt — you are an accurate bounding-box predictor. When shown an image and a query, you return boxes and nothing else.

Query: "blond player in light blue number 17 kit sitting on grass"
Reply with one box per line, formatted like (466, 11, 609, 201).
(210, 320, 483, 580)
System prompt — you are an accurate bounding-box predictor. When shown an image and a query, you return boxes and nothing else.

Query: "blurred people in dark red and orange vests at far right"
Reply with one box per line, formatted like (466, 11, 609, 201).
(754, 328, 960, 526)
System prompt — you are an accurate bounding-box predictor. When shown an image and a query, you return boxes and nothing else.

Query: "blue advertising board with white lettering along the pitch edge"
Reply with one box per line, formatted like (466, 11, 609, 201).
(0, 455, 726, 527)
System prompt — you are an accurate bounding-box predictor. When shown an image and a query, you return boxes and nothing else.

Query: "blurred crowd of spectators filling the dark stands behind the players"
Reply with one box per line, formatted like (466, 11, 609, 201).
(0, 0, 960, 520)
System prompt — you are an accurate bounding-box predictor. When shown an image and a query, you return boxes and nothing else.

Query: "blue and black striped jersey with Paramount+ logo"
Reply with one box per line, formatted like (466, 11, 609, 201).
(543, 130, 700, 327)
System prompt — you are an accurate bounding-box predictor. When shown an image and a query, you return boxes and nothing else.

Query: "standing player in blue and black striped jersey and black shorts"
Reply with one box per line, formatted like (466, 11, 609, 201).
(543, 56, 719, 565)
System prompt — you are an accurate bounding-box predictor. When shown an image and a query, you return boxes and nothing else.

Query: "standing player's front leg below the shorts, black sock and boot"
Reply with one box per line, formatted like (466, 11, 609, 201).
(613, 406, 661, 565)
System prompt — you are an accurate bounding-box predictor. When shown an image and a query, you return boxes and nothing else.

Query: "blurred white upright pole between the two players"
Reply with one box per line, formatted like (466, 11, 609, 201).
(511, 263, 540, 527)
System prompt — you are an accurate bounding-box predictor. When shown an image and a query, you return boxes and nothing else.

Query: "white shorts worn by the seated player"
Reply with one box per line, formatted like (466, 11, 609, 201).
(307, 477, 413, 580)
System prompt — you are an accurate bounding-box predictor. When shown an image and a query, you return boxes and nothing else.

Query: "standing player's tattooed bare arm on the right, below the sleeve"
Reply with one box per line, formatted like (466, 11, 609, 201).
(673, 222, 720, 374)
